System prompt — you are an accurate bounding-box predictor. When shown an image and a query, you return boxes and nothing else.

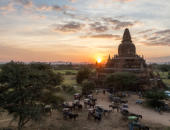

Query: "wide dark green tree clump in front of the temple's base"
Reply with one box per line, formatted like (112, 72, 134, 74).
(105, 72, 138, 90)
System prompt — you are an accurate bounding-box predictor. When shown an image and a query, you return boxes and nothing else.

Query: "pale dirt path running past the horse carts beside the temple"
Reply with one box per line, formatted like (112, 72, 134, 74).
(96, 93, 170, 126)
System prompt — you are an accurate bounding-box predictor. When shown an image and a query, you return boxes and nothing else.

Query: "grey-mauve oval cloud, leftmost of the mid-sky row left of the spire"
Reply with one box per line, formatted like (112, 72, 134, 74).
(53, 22, 84, 33)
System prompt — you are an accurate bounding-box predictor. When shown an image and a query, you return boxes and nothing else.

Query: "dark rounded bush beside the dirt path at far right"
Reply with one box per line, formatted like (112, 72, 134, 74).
(145, 91, 167, 108)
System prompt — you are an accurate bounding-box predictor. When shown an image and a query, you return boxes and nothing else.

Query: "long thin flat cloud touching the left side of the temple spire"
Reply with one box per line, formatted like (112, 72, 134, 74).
(81, 34, 121, 40)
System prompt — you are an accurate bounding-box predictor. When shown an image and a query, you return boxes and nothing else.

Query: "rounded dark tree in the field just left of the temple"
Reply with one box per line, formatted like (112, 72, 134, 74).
(76, 67, 91, 84)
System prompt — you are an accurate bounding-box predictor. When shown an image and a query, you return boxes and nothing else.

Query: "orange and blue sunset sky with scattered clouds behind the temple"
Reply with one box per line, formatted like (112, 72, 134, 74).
(0, 0, 170, 62)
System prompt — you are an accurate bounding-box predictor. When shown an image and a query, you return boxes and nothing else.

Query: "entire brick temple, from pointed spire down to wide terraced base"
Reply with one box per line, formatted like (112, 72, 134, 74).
(96, 28, 164, 88)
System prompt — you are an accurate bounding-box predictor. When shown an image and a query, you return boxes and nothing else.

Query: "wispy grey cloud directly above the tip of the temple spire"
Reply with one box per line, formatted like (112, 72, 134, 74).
(104, 18, 139, 30)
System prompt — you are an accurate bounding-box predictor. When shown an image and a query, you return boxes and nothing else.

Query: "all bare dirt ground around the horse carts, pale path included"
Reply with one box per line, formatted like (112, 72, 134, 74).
(0, 93, 170, 130)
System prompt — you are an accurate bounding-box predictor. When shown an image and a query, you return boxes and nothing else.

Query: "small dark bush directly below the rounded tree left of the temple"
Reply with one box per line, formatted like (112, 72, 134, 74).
(82, 80, 95, 95)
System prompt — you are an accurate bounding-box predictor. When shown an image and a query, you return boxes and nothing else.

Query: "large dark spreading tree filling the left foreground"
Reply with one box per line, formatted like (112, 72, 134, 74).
(0, 62, 63, 130)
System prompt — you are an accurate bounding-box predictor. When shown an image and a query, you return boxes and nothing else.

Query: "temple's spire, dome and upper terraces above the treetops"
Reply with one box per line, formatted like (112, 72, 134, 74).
(104, 29, 147, 73)
